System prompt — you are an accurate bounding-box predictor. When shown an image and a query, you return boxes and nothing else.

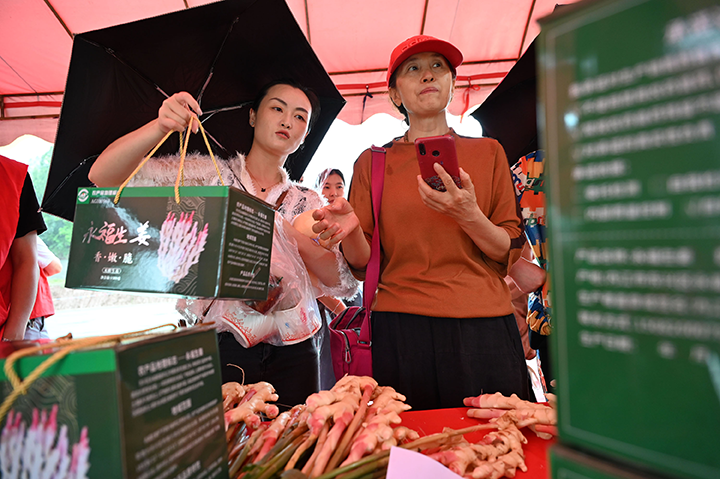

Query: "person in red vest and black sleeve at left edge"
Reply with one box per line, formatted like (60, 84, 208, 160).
(0, 156, 47, 341)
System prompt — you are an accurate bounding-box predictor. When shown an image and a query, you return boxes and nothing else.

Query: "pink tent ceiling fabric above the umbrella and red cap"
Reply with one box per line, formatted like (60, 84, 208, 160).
(0, 0, 575, 145)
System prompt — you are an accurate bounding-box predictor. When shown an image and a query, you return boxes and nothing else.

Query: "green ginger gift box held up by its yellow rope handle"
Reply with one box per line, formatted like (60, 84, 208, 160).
(65, 186, 275, 300)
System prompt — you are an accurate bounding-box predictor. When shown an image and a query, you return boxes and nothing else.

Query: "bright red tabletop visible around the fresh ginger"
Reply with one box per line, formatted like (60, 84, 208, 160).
(400, 407, 555, 479)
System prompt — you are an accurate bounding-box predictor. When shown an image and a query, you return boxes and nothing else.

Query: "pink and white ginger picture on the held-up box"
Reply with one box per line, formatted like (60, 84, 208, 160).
(158, 211, 208, 284)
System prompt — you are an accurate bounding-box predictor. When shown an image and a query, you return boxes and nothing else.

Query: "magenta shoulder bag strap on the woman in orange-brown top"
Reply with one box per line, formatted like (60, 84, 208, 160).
(358, 145, 387, 346)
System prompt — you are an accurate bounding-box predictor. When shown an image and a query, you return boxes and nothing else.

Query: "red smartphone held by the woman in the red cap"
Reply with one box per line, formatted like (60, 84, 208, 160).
(415, 135, 462, 191)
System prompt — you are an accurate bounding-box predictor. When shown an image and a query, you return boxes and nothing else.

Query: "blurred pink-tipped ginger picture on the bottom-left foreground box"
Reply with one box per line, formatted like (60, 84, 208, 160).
(0, 404, 90, 479)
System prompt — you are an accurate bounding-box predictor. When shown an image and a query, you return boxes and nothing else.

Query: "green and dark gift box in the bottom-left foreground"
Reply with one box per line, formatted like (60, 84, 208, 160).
(0, 328, 228, 479)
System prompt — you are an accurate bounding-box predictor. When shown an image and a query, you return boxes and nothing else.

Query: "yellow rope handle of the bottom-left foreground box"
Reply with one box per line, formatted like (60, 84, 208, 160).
(0, 323, 177, 422)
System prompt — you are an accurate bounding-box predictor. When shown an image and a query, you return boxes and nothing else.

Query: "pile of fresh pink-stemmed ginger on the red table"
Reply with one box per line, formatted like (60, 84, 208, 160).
(223, 376, 555, 479)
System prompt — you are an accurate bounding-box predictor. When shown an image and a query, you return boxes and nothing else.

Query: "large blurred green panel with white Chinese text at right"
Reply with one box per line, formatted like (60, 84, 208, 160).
(538, 0, 720, 478)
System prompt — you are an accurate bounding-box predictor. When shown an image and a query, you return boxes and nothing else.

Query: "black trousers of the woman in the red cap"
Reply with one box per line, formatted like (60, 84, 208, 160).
(372, 311, 529, 410)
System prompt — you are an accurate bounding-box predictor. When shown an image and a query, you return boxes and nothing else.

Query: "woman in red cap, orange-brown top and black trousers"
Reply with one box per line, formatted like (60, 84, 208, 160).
(314, 35, 528, 409)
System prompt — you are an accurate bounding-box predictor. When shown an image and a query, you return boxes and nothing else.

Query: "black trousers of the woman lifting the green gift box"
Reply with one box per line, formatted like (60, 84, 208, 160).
(218, 332, 320, 410)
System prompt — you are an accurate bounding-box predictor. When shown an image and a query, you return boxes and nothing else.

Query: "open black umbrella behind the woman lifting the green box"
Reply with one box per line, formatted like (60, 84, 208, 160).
(43, 0, 345, 220)
